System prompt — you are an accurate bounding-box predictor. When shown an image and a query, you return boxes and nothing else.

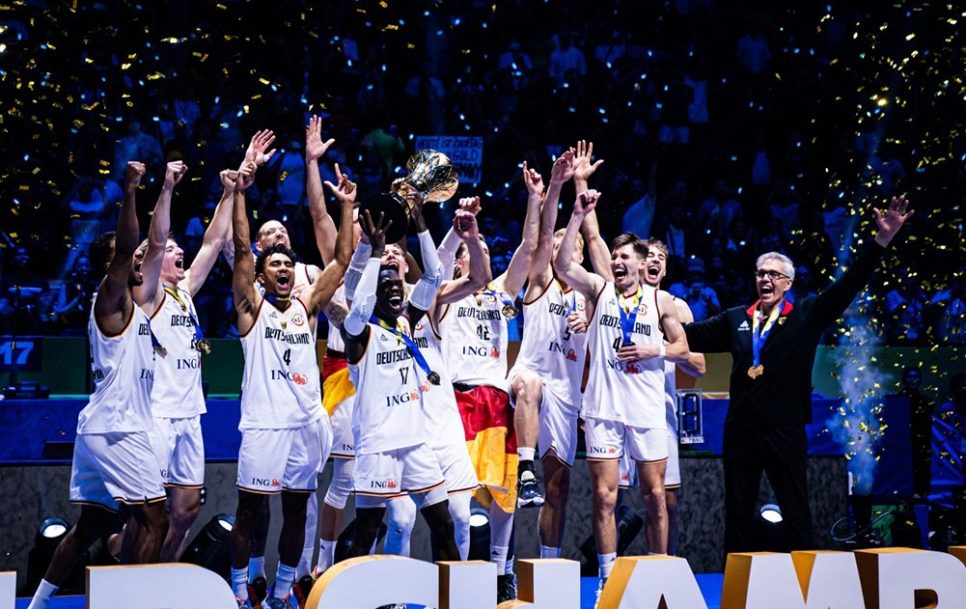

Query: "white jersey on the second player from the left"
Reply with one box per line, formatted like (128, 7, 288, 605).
(151, 287, 205, 419)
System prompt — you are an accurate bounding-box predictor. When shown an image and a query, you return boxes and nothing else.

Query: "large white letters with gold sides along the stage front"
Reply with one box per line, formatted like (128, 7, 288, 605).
(0, 547, 966, 609)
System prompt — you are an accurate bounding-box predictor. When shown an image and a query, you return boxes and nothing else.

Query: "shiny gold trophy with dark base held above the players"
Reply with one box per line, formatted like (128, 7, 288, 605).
(360, 150, 460, 243)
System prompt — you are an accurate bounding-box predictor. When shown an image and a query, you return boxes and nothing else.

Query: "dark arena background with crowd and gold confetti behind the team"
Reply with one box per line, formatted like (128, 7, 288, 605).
(0, 0, 966, 609)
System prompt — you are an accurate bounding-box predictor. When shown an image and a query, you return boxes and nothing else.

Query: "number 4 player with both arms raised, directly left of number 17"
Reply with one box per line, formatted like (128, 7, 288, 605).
(231, 163, 352, 608)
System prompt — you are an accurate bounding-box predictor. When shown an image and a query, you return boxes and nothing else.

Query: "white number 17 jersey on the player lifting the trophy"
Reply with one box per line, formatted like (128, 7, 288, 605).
(349, 318, 435, 456)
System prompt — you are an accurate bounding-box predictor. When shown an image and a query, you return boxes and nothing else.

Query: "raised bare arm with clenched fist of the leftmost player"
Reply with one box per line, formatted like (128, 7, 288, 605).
(94, 161, 145, 336)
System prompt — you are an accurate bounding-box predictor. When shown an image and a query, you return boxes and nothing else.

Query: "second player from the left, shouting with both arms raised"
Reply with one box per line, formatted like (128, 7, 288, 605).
(135, 170, 237, 562)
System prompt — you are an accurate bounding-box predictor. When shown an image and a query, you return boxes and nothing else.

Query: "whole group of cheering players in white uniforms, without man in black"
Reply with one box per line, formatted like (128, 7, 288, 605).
(30, 124, 704, 609)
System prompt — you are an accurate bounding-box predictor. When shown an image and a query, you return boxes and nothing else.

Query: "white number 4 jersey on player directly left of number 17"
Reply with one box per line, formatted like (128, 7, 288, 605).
(238, 298, 324, 430)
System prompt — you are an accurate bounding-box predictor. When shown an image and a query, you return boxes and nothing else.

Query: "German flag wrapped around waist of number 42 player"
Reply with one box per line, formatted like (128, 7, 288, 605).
(456, 385, 518, 513)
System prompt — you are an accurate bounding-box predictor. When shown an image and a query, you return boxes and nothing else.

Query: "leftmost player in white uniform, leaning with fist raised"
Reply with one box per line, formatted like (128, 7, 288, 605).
(29, 161, 170, 609)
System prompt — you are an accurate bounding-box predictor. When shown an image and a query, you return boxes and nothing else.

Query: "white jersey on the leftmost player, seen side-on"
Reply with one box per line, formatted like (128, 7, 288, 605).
(77, 295, 154, 434)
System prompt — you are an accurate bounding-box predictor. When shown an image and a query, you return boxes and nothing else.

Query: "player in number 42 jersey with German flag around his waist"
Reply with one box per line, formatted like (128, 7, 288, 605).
(438, 163, 544, 602)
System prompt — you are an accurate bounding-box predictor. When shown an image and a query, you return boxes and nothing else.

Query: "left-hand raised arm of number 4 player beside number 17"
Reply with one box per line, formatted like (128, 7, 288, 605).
(231, 163, 262, 336)
